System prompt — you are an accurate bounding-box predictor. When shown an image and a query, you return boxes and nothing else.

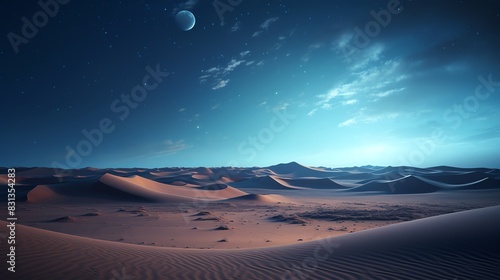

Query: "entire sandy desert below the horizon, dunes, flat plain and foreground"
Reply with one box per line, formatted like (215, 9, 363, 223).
(0, 162, 500, 279)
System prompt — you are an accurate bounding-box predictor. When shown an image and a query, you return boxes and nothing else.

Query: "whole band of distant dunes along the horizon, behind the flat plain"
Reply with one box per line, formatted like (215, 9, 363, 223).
(0, 162, 500, 203)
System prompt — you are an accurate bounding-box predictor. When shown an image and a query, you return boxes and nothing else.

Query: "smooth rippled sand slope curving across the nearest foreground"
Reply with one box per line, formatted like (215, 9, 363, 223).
(0, 206, 500, 280)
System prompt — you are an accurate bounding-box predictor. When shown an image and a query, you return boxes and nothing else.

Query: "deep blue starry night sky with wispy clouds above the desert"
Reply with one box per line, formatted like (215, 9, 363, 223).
(0, 0, 500, 168)
